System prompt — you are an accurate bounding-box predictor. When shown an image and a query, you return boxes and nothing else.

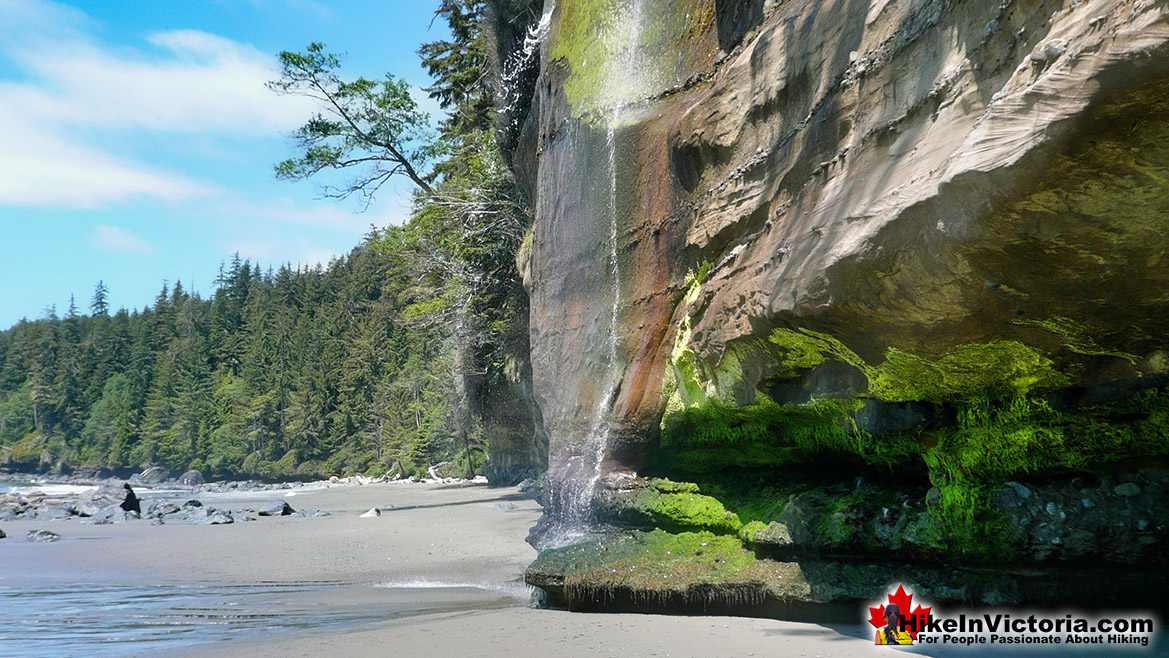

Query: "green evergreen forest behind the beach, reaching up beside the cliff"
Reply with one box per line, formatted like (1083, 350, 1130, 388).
(0, 0, 530, 479)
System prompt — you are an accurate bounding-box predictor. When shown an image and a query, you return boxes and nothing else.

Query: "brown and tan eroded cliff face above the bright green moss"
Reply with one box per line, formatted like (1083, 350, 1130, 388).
(521, 0, 1169, 486)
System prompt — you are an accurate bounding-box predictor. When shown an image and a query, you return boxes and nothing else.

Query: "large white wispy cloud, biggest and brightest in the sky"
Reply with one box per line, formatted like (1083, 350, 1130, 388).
(0, 0, 312, 208)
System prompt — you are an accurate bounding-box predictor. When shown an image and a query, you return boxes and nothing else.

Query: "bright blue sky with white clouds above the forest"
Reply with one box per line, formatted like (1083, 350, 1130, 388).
(0, 0, 448, 330)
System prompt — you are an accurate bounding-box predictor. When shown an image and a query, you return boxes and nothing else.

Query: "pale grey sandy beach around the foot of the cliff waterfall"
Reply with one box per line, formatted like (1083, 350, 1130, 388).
(0, 484, 1150, 658)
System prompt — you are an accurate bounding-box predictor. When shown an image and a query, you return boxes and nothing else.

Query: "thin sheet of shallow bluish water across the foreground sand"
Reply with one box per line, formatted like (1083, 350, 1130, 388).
(0, 583, 521, 658)
